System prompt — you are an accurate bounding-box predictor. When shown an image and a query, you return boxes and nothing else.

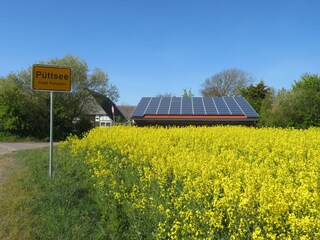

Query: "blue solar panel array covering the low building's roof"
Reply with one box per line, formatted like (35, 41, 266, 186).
(132, 97, 259, 118)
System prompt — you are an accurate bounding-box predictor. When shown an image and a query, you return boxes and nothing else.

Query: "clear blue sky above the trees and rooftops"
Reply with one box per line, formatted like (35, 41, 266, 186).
(0, 0, 320, 105)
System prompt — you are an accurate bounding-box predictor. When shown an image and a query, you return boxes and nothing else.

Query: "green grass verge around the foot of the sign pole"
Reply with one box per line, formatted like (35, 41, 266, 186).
(0, 149, 108, 239)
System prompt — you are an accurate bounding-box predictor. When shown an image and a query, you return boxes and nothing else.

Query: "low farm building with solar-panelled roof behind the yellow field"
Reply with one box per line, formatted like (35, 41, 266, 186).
(131, 97, 259, 126)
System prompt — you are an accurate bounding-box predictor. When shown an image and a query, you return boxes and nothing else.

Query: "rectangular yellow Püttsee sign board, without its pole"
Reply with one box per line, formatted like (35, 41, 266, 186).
(32, 64, 71, 92)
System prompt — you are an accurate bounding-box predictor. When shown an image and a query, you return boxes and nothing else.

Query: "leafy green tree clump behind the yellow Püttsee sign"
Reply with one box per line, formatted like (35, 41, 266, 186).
(0, 55, 119, 139)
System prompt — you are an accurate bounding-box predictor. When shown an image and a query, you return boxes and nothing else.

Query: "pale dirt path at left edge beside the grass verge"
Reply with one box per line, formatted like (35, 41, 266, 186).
(0, 142, 49, 186)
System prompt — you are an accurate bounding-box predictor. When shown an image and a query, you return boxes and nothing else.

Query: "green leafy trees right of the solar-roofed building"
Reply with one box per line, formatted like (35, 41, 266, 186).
(241, 73, 320, 129)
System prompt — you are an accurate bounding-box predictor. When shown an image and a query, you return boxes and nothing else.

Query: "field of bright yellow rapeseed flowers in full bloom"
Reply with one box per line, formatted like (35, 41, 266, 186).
(65, 126, 320, 239)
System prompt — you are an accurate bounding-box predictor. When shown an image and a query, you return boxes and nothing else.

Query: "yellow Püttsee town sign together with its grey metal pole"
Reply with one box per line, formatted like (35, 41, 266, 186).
(32, 64, 71, 178)
